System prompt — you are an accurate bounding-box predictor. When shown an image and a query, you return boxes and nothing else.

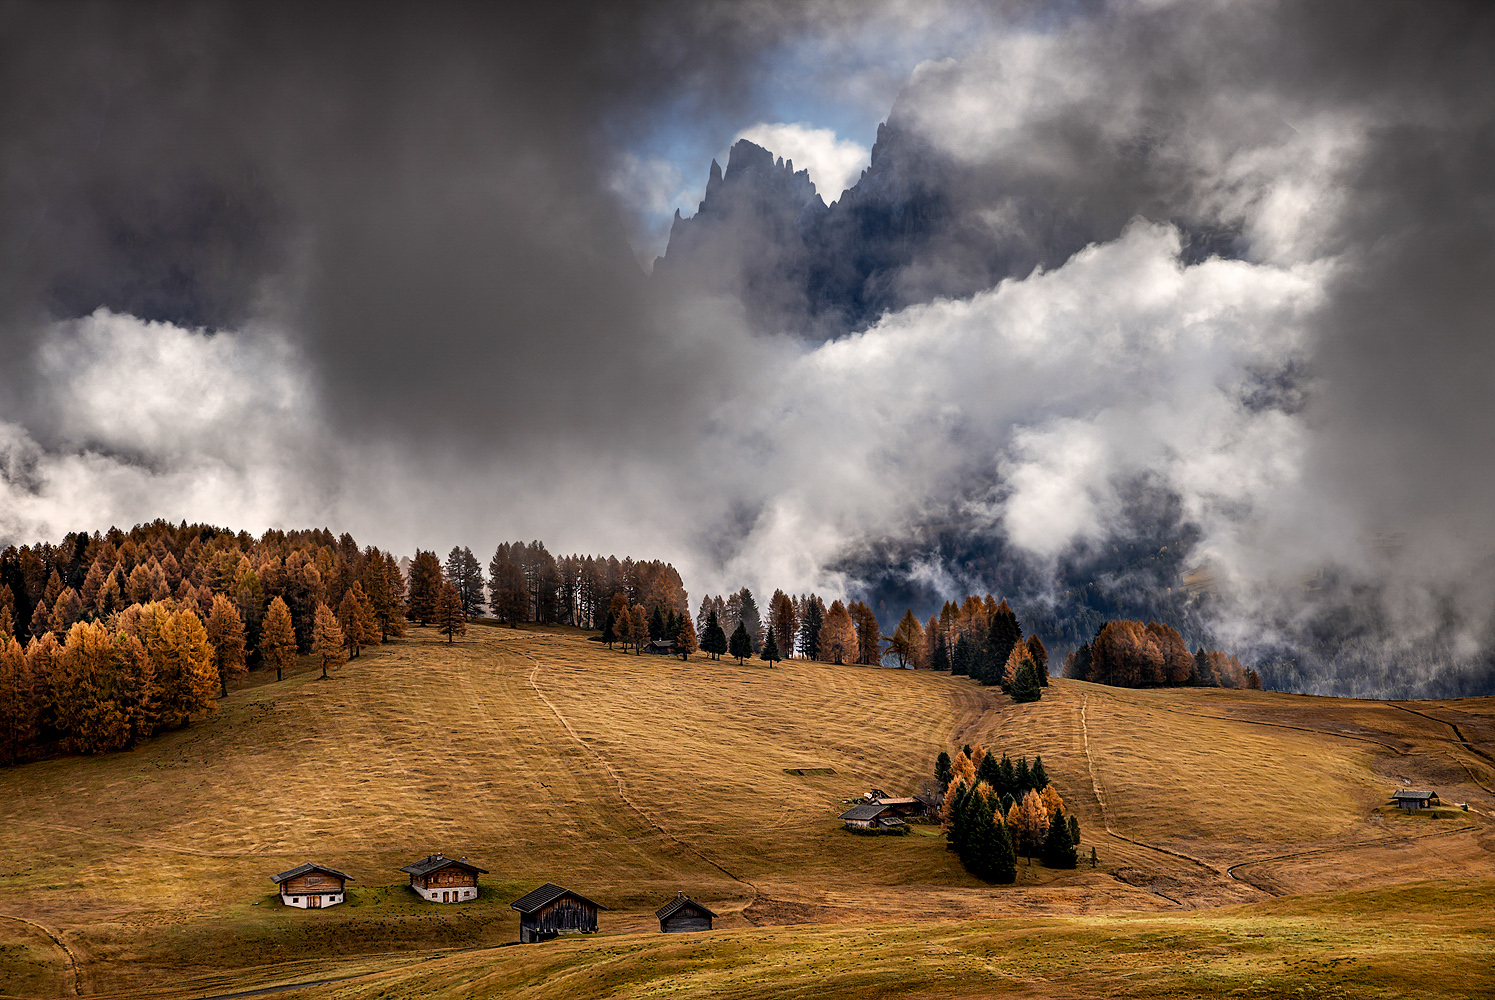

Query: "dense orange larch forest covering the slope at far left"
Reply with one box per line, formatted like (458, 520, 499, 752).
(0, 520, 415, 761)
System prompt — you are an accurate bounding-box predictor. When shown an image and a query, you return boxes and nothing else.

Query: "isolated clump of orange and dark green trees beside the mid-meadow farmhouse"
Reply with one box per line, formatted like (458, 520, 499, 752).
(934, 744, 1079, 883)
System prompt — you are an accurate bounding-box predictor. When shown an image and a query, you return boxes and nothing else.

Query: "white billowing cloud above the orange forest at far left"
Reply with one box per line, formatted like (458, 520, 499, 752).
(0, 309, 336, 541)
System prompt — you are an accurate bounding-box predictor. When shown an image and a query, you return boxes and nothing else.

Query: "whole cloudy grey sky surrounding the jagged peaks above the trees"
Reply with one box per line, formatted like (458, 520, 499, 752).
(0, 1, 1495, 691)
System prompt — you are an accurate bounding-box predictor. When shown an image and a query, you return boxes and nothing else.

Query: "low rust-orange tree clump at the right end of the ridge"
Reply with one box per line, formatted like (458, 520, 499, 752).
(1064, 620, 1262, 691)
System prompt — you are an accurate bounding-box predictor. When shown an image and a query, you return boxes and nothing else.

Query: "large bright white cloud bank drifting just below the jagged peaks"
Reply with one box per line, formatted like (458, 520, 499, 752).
(684, 221, 1329, 600)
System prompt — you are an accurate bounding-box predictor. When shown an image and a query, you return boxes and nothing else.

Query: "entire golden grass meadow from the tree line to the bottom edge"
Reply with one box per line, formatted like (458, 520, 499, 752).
(0, 625, 1495, 997)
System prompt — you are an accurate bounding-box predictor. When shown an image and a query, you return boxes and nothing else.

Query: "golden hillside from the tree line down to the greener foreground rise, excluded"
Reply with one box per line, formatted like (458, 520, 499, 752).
(0, 626, 1495, 996)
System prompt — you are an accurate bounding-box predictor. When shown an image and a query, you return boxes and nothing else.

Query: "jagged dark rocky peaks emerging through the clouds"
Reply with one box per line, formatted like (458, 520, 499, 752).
(655, 112, 1235, 339)
